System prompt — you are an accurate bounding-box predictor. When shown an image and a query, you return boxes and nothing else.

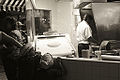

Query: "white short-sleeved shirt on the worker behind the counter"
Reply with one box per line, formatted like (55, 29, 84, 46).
(76, 20, 92, 44)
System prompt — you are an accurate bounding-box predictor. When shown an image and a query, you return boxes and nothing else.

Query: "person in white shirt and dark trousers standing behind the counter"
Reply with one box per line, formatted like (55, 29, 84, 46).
(76, 14, 98, 57)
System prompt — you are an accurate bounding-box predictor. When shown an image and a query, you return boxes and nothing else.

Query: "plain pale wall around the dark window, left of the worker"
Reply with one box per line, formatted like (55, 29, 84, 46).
(27, 0, 77, 56)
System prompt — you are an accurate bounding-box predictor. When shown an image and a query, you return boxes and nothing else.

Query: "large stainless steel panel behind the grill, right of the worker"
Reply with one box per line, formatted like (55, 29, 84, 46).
(92, 3, 120, 41)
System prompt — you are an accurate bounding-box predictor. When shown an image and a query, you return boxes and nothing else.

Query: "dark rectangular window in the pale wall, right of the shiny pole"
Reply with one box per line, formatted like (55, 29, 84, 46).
(34, 9, 51, 35)
